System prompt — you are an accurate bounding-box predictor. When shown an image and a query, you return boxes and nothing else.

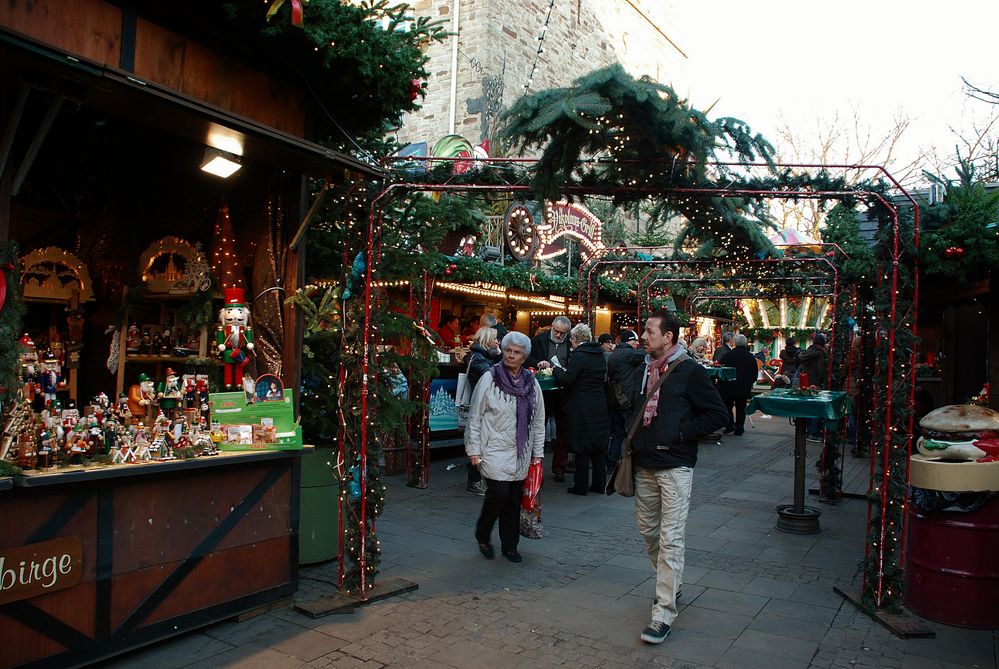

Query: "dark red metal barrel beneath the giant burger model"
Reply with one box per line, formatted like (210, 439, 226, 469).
(905, 499, 999, 629)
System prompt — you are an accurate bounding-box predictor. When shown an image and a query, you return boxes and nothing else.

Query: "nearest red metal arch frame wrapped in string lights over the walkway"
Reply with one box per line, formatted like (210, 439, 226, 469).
(362, 156, 919, 607)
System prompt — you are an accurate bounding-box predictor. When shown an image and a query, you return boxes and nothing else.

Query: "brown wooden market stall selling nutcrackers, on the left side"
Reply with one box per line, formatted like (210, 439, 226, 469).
(0, 0, 377, 667)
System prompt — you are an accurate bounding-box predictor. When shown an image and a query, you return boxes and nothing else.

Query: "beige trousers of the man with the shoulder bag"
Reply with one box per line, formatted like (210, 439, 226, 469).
(635, 466, 694, 625)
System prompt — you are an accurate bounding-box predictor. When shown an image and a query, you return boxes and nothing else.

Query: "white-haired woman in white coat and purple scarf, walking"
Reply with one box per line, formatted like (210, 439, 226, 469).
(465, 332, 545, 562)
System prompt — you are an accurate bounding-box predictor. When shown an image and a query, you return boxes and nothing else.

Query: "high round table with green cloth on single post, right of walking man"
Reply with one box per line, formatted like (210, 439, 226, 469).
(746, 388, 853, 534)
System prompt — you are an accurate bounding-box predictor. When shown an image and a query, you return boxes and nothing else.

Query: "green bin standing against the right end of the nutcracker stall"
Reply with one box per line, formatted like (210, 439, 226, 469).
(298, 446, 340, 564)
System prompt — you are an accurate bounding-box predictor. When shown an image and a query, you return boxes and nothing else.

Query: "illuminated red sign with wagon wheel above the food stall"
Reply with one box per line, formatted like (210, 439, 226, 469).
(504, 202, 604, 261)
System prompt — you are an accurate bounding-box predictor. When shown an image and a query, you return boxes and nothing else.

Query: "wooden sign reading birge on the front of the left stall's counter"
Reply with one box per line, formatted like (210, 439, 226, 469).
(0, 537, 83, 605)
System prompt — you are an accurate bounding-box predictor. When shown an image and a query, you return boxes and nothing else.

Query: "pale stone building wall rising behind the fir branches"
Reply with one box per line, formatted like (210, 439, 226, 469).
(397, 0, 686, 154)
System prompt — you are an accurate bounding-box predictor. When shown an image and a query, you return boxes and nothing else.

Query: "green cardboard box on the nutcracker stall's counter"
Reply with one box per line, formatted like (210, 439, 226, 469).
(209, 388, 302, 451)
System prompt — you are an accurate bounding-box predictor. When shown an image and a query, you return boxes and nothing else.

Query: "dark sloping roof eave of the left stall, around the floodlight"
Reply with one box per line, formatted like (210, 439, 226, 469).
(0, 27, 382, 178)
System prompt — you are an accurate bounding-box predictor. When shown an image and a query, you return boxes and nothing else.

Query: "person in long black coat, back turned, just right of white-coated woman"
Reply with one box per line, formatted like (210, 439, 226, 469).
(553, 323, 610, 495)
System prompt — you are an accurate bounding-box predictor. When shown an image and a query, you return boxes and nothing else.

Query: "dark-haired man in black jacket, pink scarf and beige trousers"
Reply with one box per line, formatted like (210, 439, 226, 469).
(629, 311, 728, 643)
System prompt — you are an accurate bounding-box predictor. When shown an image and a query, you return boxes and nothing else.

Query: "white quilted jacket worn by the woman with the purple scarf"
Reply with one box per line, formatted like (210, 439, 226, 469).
(465, 363, 545, 481)
